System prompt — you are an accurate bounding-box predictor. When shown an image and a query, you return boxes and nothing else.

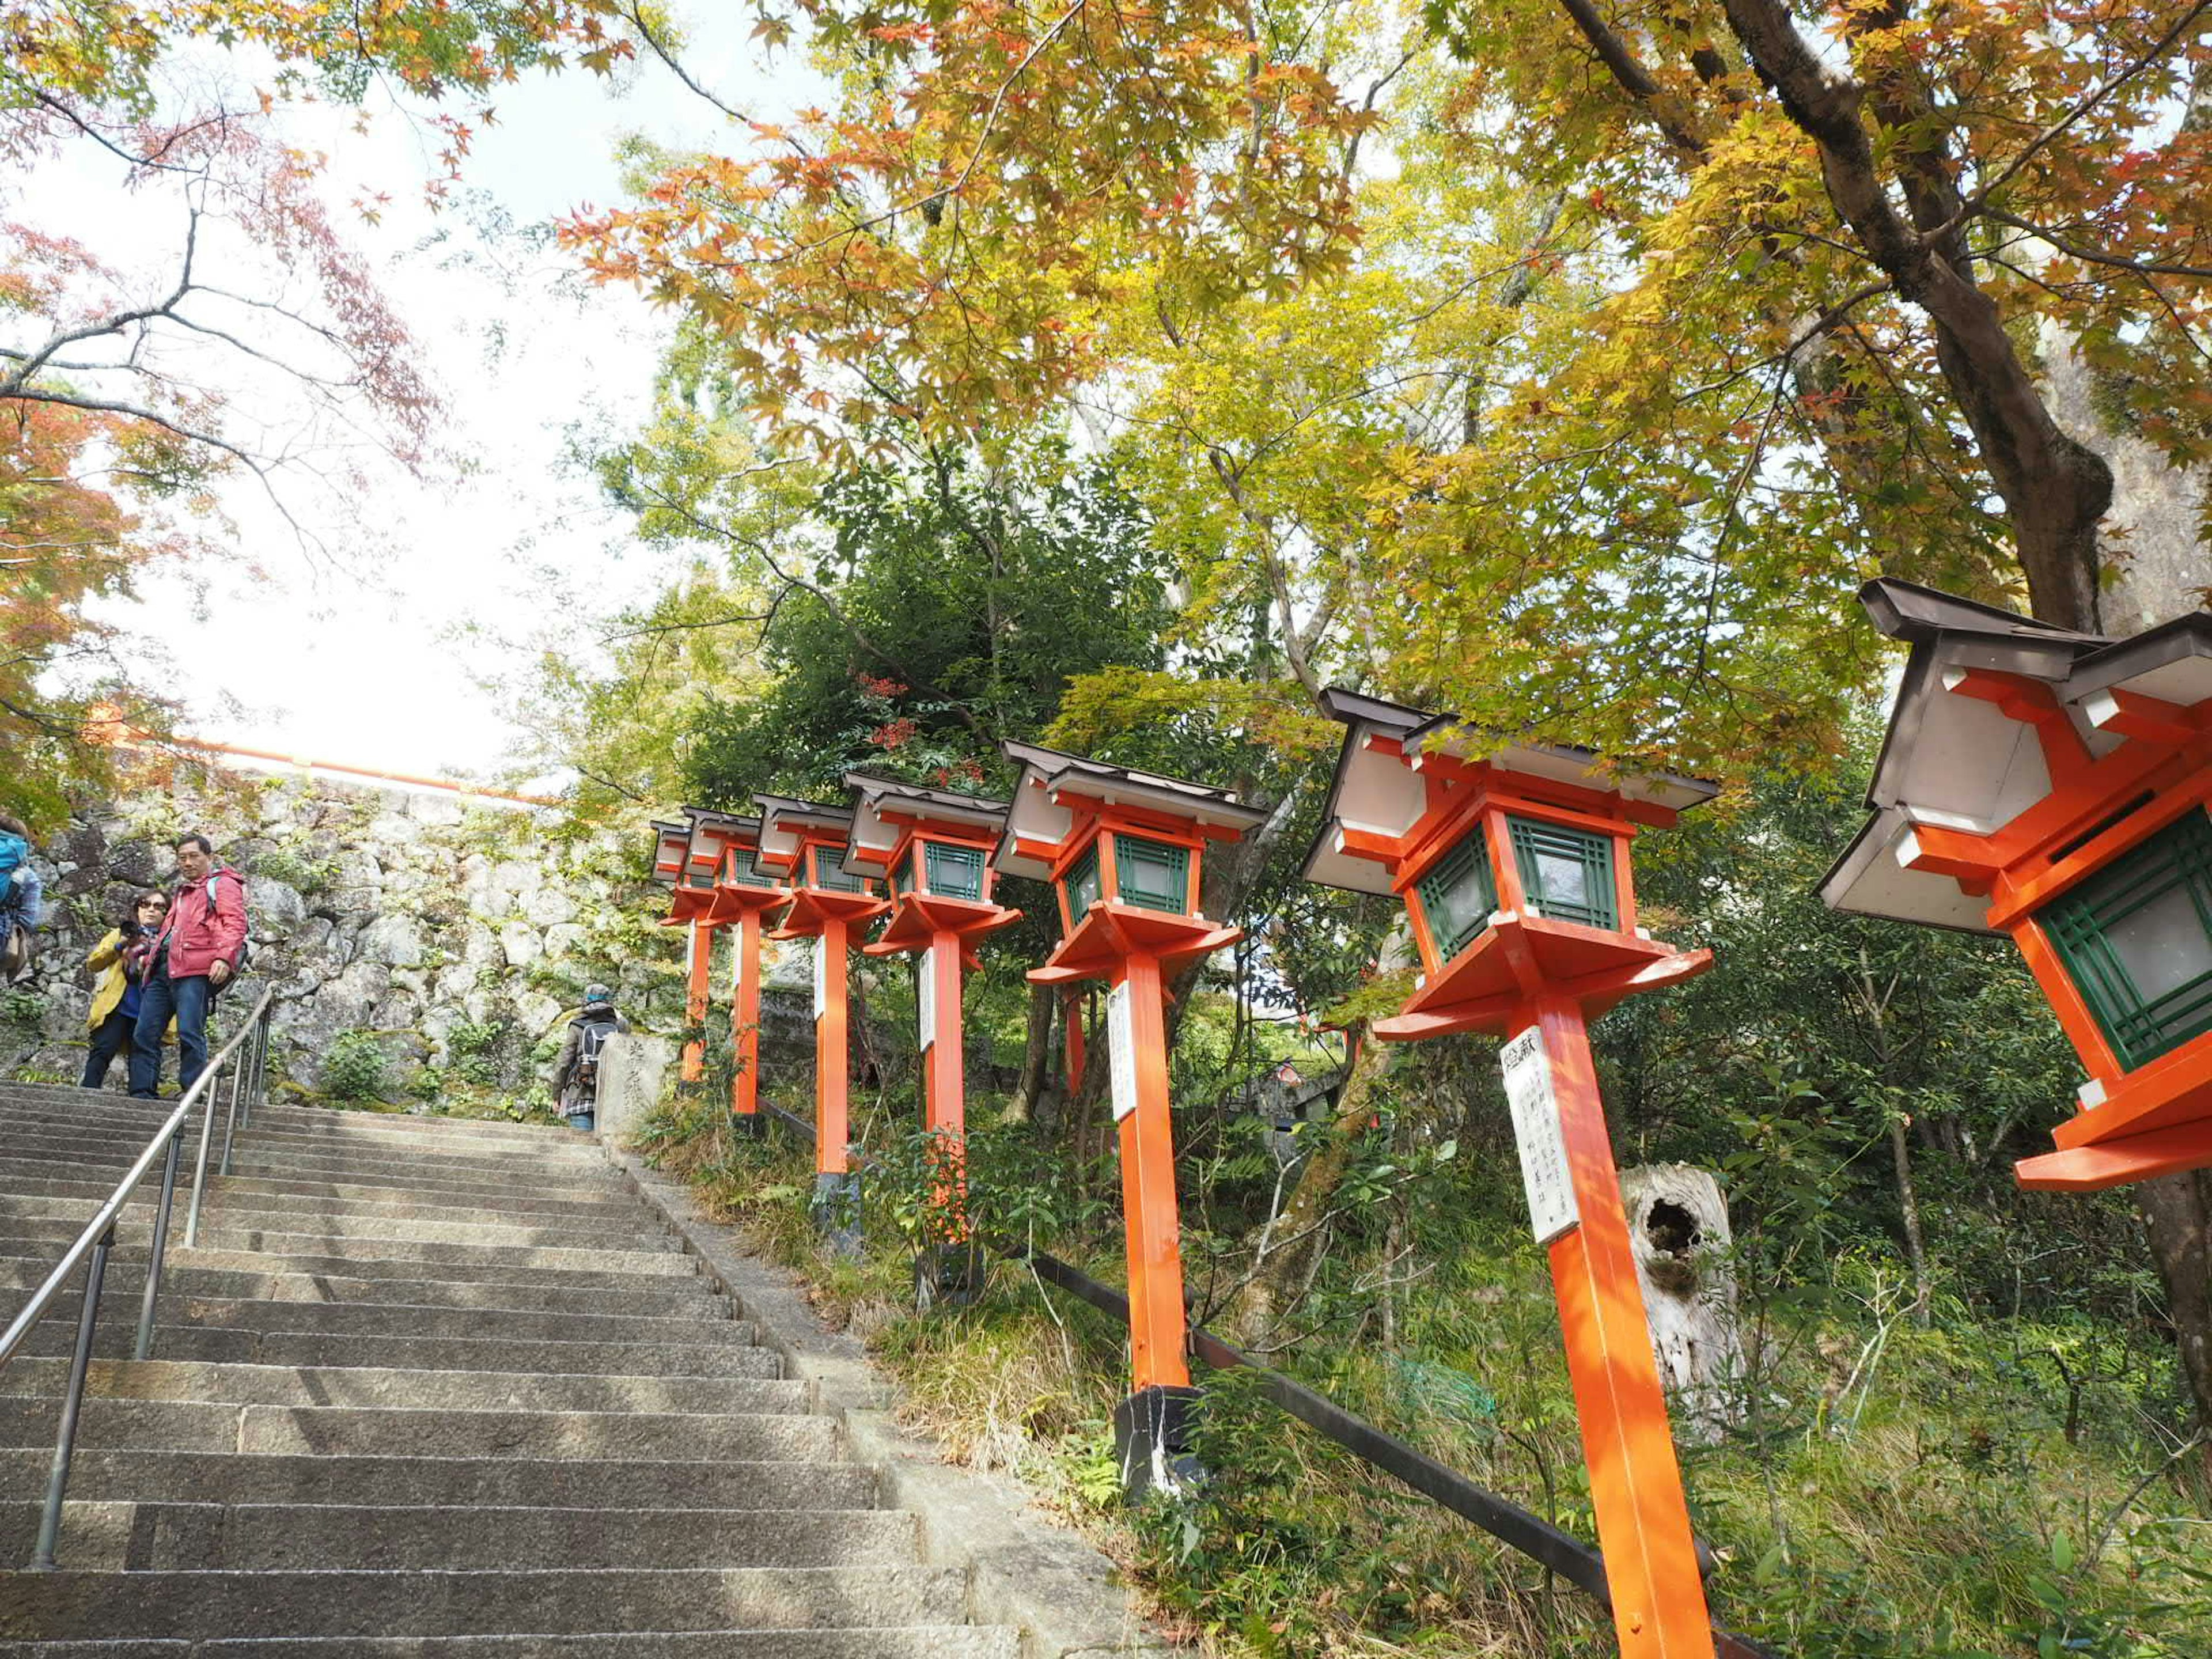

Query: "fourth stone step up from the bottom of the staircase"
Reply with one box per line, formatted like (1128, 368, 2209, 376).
(0, 1445, 876, 1521)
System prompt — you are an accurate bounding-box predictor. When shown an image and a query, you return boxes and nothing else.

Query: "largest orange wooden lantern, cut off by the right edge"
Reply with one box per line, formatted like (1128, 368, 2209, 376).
(1820, 579, 2212, 1192)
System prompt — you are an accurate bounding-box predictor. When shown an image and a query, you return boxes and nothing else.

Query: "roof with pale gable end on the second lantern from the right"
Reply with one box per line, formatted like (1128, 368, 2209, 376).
(1305, 685, 1721, 893)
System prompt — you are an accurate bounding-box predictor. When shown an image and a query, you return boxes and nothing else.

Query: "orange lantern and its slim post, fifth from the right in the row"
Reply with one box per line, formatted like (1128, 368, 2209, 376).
(754, 794, 889, 1250)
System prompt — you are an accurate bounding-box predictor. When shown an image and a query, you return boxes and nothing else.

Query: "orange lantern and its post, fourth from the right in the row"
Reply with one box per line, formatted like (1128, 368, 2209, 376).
(845, 772, 1022, 1305)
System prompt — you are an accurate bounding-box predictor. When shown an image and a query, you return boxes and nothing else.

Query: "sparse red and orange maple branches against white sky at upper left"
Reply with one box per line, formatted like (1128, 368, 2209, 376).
(0, 0, 628, 823)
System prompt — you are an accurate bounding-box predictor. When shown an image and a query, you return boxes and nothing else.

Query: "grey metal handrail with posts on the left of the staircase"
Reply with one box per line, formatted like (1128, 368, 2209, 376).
(0, 988, 276, 1570)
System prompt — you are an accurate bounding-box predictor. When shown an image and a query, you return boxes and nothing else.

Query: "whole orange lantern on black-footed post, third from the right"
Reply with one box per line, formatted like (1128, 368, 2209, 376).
(998, 743, 1267, 1495)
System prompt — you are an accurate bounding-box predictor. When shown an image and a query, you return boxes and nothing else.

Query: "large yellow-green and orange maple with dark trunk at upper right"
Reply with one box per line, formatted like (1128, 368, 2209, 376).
(569, 0, 2212, 1420)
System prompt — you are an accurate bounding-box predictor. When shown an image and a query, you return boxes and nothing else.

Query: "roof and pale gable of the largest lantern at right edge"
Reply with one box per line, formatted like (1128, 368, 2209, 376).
(1820, 577, 2212, 933)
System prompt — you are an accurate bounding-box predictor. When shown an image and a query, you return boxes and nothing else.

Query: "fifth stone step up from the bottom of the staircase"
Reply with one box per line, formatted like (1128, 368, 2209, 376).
(0, 1396, 843, 1462)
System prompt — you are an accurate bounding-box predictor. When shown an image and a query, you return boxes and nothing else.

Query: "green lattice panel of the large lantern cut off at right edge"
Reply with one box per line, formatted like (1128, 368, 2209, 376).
(2035, 808, 2212, 1071)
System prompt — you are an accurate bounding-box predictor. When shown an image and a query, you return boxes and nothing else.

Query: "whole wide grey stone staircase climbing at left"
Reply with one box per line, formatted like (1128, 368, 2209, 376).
(0, 1086, 1020, 1659)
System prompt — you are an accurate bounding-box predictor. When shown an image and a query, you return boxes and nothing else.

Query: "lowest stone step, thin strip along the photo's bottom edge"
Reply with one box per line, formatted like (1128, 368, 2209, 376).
(0, 1624, 1022, 1659)
